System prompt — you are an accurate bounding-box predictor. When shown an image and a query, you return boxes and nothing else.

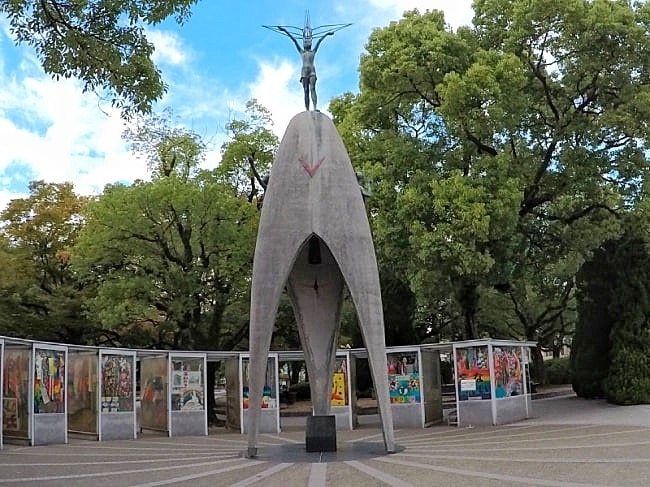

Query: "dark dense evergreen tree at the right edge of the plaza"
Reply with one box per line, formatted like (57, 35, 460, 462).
(571, 208, 650, 404)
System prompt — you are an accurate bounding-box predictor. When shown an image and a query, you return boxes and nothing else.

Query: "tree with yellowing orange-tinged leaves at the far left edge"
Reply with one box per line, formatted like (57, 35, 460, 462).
(0, 181, 88, 343)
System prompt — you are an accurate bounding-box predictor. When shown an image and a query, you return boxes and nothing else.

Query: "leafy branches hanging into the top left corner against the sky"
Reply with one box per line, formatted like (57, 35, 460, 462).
(0, 0, 197, 116)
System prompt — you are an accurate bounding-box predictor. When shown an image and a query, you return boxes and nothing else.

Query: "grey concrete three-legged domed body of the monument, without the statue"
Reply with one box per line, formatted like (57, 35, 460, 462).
(248, 112, 394, 456)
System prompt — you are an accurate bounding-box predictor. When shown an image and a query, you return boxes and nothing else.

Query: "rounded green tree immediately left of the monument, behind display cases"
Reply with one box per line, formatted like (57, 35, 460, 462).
(73, 117, 258, 349)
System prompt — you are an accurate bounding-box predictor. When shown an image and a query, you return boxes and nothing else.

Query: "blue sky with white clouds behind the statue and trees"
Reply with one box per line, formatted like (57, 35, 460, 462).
(0, 0, 472, 209)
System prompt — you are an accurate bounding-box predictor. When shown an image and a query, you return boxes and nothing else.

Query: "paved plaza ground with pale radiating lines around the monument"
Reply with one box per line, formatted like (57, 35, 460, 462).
(0, 396, 650, 487)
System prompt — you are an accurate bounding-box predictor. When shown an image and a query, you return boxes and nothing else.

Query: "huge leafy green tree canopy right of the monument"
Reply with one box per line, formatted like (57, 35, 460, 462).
(331, 0, 650, 370)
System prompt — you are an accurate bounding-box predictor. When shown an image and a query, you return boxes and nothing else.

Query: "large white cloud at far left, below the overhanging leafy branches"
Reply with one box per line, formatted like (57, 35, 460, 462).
(0, 47, 147, 212)
